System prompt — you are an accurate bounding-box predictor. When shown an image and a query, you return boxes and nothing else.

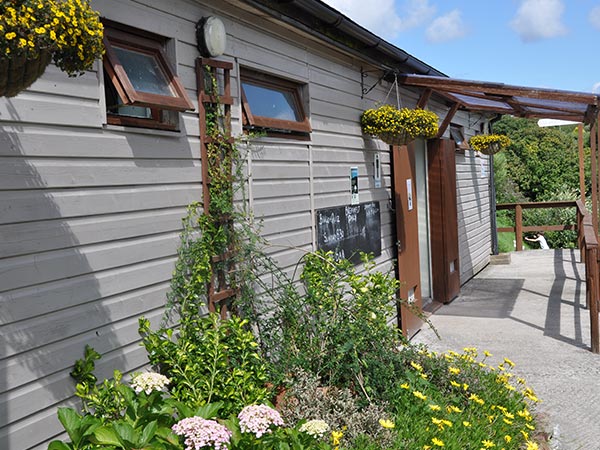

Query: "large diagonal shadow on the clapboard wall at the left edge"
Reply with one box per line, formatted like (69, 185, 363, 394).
(0, 100, 123, 450)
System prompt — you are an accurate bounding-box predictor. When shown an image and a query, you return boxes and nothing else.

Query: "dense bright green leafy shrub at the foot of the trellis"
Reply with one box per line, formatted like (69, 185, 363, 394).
(139, 314, 270, 415)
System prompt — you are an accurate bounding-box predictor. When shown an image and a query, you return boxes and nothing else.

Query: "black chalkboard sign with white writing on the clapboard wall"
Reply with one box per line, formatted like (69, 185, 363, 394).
(317, 202, 381, 264)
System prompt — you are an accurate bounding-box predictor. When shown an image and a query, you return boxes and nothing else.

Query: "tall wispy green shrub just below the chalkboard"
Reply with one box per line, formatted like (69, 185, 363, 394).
(244, 251, 399, 397)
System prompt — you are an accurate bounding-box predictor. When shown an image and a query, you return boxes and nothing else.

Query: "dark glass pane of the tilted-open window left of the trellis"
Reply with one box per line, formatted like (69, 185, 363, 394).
(112, 44, 176, 97)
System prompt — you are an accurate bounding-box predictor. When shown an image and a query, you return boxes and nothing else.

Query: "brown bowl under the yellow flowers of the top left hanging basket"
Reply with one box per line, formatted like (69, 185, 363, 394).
(0, 51, 52, 97)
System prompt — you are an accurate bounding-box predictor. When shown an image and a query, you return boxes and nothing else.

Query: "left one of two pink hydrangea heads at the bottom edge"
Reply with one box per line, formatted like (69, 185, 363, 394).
(172, 416, 231, 450)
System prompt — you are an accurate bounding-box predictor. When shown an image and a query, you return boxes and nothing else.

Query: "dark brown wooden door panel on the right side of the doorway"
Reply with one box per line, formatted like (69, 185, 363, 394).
(427, 139, 460, 303)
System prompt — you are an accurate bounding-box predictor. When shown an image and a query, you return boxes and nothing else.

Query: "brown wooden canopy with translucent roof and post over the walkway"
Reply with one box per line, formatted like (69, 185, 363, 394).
(398, 75, 600, 353)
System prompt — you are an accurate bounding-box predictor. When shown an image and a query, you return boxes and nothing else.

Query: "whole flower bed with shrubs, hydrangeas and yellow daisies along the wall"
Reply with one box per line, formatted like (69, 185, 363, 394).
(49, 253, 539, 450)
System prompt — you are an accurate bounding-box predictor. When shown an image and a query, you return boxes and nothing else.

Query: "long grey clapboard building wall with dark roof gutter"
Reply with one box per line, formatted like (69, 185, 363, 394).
(0, 0, 491, 450)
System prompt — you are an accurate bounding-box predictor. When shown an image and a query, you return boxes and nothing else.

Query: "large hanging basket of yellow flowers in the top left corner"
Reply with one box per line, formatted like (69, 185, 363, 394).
(0, 0, 104, 97)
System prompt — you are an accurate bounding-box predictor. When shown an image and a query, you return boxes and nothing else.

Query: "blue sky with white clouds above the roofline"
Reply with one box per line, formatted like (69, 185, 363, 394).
(323, 0, 600, 93)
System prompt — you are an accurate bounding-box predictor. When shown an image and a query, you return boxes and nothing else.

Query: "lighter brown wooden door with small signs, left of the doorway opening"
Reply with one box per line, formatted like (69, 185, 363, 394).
(392, 144, 422, 337)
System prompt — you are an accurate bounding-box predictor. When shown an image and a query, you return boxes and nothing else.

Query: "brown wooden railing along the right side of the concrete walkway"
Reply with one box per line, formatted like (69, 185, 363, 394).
(496, 200, 600, 353)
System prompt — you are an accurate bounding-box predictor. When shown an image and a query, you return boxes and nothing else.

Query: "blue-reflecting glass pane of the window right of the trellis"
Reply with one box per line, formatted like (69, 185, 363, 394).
(242, 81, 303, 122)
